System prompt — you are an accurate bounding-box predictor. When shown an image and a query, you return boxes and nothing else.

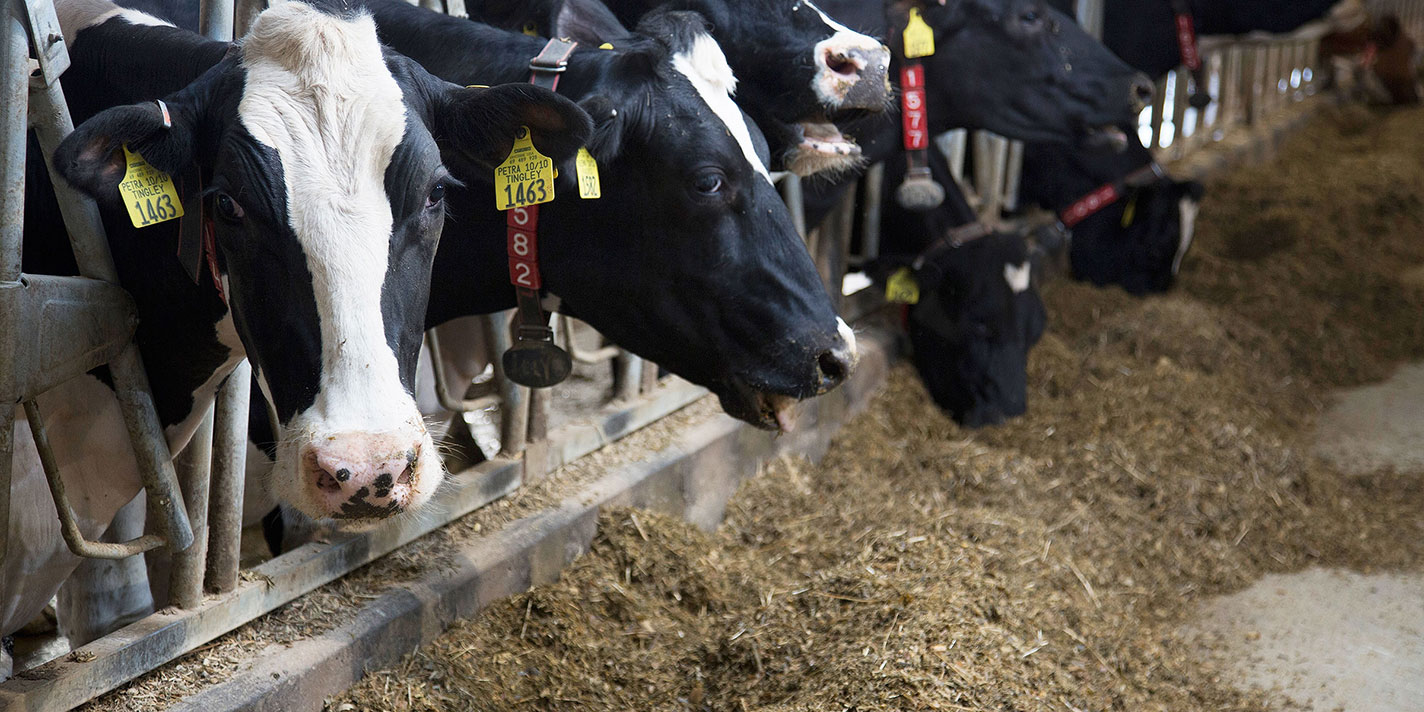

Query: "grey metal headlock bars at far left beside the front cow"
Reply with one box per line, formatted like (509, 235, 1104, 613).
(0, 0, 192, 560)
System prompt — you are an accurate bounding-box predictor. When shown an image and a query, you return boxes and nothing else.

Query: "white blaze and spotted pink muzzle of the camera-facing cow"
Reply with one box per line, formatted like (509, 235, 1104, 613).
(238, 3, 441, 520)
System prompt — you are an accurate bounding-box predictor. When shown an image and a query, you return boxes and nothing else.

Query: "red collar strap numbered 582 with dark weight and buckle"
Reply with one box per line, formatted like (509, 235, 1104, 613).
(504, 37, 578, 387)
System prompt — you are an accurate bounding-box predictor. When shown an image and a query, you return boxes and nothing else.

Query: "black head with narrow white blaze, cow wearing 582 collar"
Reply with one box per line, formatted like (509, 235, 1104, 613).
(540, 10, 856, 429)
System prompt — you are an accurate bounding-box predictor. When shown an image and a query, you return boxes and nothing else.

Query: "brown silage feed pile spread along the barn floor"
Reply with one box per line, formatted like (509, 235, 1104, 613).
(328, 110, 1424, 712)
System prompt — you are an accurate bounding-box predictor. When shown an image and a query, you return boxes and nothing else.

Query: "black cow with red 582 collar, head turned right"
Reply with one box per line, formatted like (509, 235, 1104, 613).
(369, 0, 856, 429)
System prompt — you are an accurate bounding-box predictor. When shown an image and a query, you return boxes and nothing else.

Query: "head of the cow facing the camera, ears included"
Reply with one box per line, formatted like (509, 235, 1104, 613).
(54, 3, 588, 524)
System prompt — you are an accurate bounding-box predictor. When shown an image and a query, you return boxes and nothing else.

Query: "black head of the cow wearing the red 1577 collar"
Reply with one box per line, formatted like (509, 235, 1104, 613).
(890, 0, 1152, 148)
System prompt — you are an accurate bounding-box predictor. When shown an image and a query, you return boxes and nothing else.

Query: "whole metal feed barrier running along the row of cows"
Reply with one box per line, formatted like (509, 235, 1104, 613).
(0, 0, 1401, 711)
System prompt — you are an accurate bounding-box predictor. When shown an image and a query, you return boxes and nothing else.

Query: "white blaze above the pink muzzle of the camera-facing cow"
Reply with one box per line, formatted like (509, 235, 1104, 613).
(238, 3, 414, 431)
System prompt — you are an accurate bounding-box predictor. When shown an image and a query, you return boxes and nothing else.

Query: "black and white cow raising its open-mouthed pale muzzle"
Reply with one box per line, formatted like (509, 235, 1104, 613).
(466, 0, 891, 175)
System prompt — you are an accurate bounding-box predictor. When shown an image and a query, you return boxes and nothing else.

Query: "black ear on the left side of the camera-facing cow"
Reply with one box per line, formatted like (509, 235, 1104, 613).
(54, 100, 197, 202)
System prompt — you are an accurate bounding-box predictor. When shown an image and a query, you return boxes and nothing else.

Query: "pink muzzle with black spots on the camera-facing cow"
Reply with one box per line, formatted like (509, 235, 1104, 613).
(269, 412, 444, 531)
